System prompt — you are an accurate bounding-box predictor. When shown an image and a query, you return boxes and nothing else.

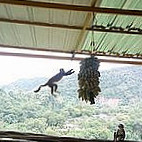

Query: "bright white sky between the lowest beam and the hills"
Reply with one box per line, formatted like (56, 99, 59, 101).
(0, 56, 129, 85)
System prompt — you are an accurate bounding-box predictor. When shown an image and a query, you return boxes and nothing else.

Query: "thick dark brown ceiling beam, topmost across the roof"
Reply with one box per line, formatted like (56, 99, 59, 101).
(0, 0, 142, 16)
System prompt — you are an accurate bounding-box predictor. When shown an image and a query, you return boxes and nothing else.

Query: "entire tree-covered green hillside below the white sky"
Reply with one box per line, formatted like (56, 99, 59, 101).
(0, 66, 142, 140)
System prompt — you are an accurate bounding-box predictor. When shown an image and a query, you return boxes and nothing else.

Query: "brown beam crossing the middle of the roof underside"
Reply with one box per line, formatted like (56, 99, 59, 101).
(0, 18, 142, 35)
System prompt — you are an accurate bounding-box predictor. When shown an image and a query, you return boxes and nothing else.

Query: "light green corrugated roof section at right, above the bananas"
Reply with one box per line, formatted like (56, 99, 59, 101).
(82, 0, 142, 55)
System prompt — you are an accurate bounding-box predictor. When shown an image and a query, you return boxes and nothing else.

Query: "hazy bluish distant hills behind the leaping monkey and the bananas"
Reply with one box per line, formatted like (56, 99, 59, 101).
(2, 66, 142, 98)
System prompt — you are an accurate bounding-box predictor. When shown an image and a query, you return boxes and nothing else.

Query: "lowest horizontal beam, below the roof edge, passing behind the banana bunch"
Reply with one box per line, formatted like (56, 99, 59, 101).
(0, 52, 142, 65)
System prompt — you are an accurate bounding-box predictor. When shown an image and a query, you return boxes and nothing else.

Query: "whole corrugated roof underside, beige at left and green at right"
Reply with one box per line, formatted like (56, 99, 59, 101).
(0, 0, 142, 58)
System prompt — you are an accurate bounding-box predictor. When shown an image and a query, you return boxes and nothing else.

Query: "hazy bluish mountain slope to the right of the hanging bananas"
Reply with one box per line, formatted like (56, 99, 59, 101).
(100, 66, 142, 98)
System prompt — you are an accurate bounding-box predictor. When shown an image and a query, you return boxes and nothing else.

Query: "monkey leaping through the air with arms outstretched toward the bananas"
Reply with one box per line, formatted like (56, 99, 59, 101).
(34, 69, 75, 95)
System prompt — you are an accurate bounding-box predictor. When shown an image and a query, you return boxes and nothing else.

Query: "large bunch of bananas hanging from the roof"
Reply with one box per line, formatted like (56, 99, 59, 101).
(78, 56, 101, 104)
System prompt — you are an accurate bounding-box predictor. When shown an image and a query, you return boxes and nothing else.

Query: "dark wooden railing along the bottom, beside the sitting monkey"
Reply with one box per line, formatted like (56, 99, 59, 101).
(0, 131, 140, 142)
